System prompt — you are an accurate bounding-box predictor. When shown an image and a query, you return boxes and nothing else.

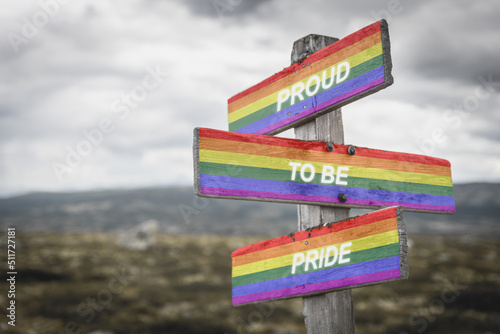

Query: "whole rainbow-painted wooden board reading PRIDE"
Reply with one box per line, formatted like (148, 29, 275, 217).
(231, 207, 408, 305)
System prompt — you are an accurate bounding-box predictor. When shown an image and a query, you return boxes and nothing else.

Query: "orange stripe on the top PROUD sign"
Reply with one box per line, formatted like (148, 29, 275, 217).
(228, 30, 382, 113)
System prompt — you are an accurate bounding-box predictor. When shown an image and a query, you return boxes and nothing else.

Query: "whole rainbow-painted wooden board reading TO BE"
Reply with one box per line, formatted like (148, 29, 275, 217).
(193, 128, 455, 214)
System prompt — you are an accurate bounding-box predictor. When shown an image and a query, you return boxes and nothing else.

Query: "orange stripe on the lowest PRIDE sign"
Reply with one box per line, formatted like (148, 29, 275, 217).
(233, 217, 398, 268)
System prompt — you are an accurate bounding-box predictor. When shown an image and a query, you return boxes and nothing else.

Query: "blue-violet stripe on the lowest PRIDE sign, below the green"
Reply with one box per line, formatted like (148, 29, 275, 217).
(233, 255, 400, 297)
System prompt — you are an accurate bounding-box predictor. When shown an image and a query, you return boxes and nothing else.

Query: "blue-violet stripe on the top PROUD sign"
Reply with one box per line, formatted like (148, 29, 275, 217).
(235, 66, 385, 134)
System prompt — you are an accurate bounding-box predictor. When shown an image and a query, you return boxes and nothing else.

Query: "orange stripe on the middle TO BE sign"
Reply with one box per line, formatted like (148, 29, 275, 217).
(199, 137, 450, 176)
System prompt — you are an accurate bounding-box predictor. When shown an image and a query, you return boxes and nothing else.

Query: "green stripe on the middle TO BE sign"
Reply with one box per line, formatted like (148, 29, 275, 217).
(200, 161, 453, 196)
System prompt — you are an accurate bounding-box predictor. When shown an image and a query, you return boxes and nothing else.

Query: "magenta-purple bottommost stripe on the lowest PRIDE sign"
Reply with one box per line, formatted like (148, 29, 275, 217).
(233, 269, 401, 305)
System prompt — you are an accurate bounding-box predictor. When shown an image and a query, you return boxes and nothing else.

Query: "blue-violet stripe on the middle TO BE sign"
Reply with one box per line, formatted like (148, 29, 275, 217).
(200, 174, 455, 206)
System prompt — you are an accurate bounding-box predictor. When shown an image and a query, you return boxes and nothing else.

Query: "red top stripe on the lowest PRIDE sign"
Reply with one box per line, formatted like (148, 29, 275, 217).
(231, 207, 397, 257)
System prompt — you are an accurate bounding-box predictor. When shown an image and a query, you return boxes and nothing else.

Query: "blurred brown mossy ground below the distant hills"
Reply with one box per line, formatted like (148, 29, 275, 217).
(0, 232, 500, 334)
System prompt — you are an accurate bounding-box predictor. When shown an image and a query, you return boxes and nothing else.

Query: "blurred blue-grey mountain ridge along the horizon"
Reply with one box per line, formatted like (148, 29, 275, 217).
(0, 183, 500, 237)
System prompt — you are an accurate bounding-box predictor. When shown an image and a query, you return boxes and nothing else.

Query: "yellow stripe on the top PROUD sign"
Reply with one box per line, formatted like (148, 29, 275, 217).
(229, 43, 382, 123)
